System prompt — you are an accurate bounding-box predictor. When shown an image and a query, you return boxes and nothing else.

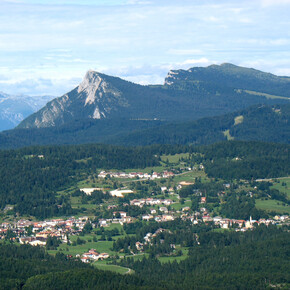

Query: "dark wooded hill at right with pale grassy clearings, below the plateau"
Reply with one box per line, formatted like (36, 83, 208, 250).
(111, 105, 290, 145)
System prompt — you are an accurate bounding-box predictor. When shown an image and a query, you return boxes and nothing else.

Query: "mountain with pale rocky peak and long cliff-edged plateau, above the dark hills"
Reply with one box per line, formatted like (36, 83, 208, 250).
(18, 64, 290, 128)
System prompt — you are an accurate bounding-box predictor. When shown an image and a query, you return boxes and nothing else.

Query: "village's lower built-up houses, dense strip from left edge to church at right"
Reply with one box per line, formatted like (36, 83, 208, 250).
(0, 198, 289, 263)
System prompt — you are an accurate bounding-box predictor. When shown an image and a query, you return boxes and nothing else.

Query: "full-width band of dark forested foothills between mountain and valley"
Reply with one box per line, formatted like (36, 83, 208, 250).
(0, 105, 290, 149)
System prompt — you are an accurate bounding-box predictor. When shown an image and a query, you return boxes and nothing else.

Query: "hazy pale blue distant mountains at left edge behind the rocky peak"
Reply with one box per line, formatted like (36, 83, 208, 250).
(0, 92, 53, 131)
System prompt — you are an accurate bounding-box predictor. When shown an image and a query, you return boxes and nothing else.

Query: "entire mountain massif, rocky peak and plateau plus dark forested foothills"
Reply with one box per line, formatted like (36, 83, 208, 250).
(0, 64, 290, 148)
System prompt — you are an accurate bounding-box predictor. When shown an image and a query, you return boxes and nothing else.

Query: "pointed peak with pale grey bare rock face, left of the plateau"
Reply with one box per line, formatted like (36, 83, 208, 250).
(18, 71, 129, 128)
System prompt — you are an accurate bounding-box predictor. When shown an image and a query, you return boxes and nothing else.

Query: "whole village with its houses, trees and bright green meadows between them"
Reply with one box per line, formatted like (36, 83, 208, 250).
(0, 160, 289, 264)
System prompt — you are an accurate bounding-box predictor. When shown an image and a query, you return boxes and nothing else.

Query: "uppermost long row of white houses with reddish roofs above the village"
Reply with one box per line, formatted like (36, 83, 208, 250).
(98, 171, 174, 180)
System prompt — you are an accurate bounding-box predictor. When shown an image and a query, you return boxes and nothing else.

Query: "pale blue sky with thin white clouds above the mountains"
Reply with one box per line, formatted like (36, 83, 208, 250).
(0, 0, 290, 96)
